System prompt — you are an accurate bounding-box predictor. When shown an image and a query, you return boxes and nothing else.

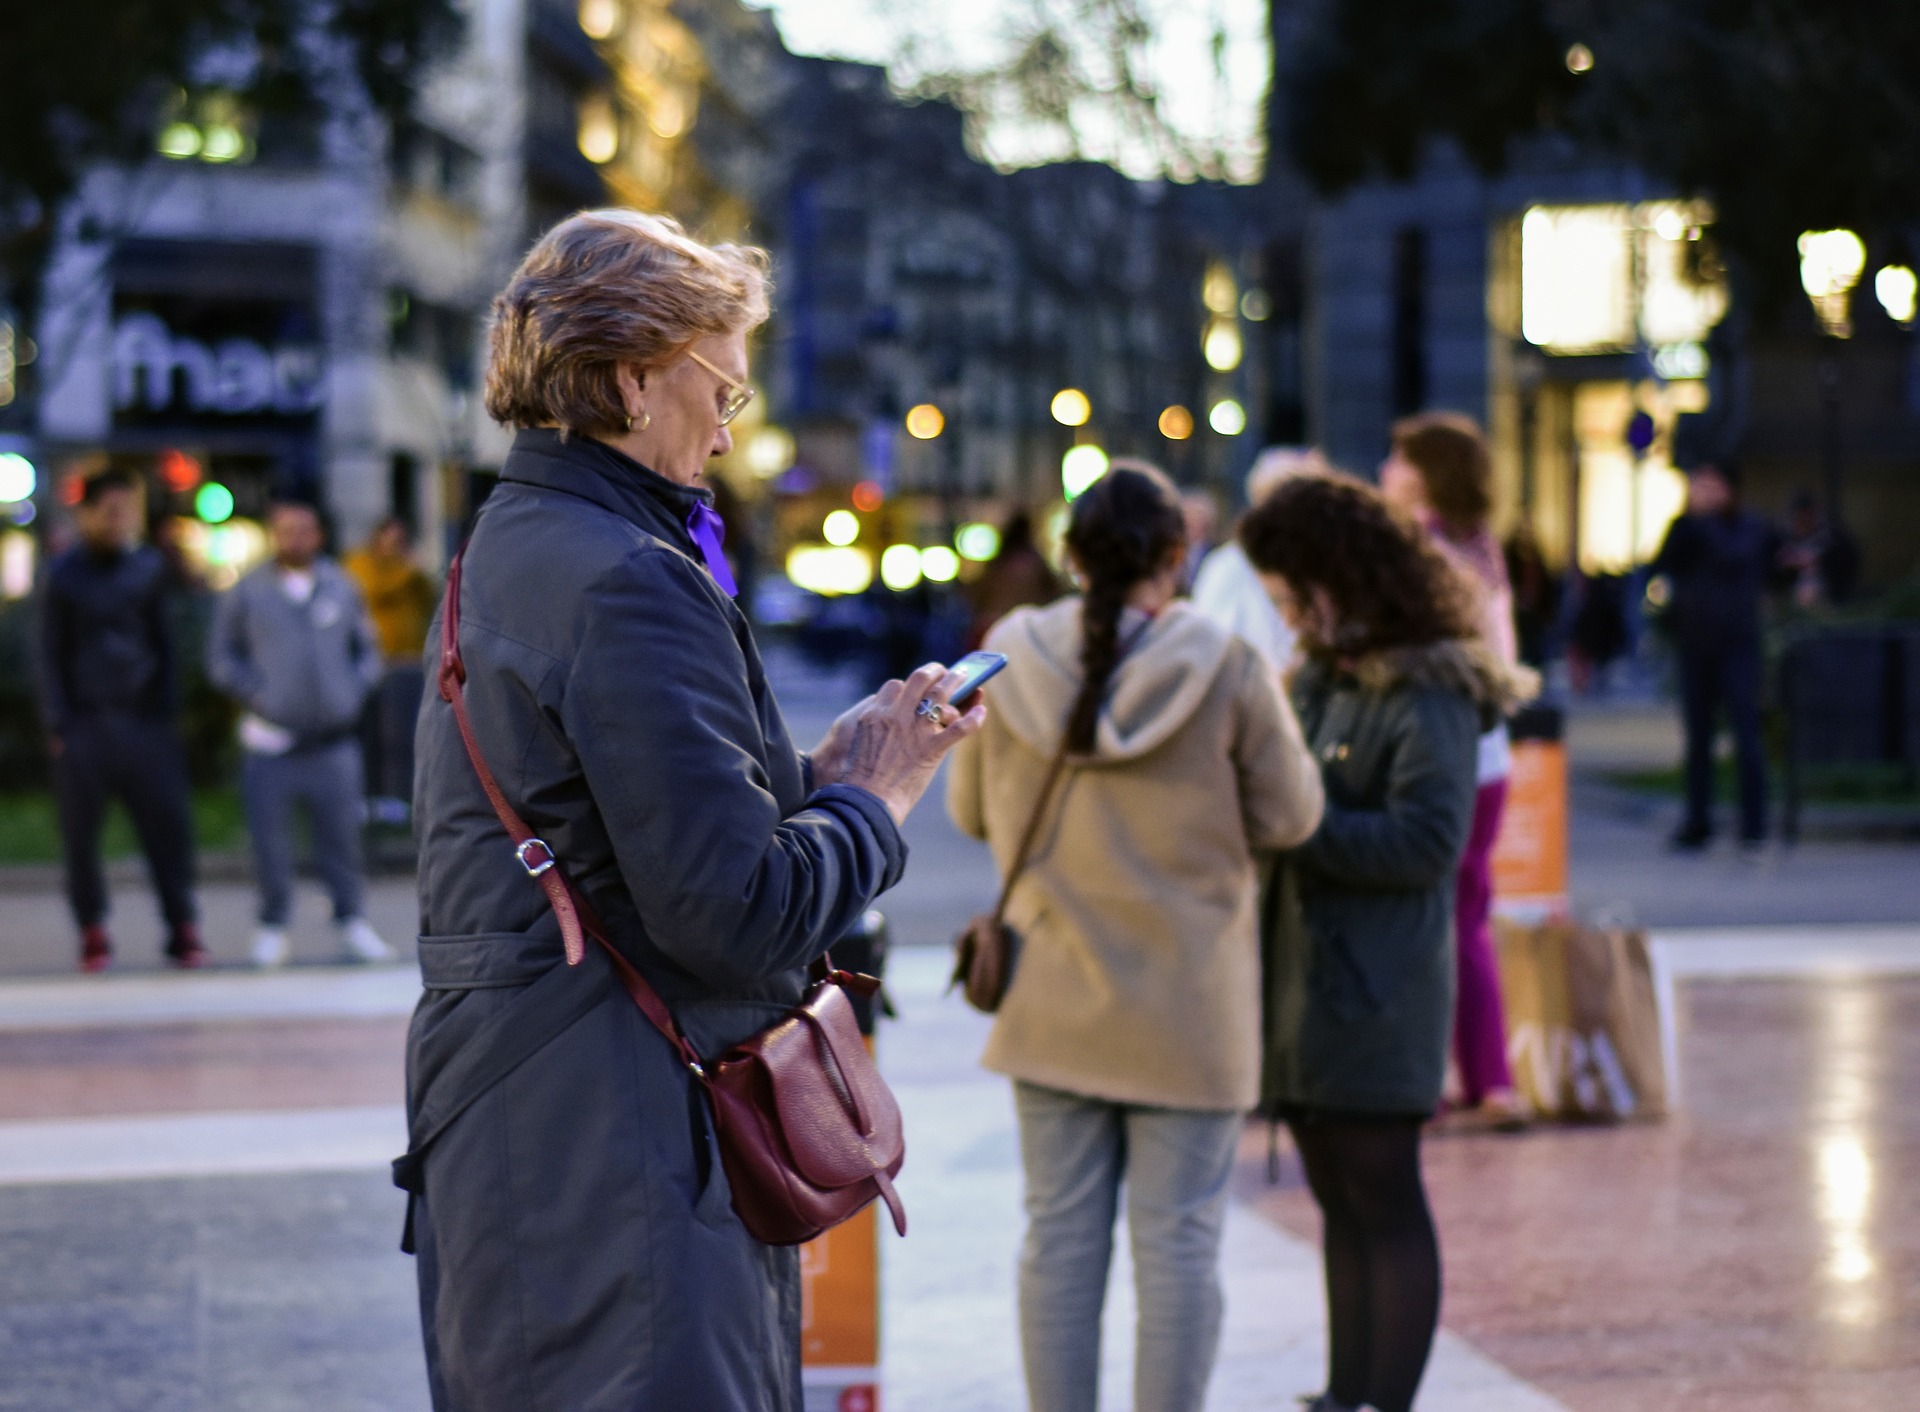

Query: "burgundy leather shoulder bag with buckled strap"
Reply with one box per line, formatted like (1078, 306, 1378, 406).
(440, 557, 906, 1245)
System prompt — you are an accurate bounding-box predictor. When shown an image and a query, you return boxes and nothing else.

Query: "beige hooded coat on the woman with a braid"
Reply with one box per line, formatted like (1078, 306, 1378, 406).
(947, 597, 1323, 1110)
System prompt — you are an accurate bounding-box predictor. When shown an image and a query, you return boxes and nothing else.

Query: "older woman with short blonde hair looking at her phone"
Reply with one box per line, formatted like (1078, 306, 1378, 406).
(397, 211, 985, 1412)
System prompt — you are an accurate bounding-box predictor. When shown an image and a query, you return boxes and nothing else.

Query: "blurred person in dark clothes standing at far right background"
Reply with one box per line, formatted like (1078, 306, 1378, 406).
(1649, 461, 1782, 853)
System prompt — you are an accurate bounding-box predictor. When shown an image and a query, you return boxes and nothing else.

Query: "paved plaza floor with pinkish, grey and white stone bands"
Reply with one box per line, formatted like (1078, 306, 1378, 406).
(0, 680, 1920, 1412)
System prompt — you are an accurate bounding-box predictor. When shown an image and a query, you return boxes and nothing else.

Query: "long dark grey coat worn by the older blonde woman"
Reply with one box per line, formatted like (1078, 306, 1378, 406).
(407, 430, 906, 1412)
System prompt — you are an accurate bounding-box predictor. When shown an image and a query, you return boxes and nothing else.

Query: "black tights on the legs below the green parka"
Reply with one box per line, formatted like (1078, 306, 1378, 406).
(1288, 1114, 1440, 1412)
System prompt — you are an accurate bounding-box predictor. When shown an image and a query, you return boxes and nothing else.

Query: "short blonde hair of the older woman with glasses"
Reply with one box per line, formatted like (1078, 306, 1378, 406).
(486, 209, 770, 434)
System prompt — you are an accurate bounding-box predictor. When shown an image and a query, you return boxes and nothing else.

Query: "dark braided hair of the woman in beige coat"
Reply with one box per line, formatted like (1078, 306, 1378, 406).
(1068, 461, 1187, 755)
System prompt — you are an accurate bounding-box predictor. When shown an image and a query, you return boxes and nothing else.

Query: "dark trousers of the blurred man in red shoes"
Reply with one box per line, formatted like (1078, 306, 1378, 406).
(54, 711, 194, 928)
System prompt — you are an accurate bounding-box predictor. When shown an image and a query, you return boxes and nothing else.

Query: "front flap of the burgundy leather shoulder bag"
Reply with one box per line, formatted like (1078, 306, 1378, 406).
(741, 984, 906, 1191)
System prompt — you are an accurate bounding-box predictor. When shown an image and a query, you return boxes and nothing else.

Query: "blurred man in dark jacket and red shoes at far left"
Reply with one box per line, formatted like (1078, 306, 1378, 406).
(38, 471, 207, 970)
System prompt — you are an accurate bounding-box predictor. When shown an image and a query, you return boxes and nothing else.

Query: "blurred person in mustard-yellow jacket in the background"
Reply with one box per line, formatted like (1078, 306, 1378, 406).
(340, 519, 440, 822)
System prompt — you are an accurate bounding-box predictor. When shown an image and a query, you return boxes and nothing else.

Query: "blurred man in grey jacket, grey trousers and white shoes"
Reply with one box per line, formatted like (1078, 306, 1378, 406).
(207, 499, 394, 966)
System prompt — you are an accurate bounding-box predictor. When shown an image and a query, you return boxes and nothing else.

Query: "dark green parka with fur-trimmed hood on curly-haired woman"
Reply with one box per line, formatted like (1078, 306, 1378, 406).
(1261, 642, 1523, 1114)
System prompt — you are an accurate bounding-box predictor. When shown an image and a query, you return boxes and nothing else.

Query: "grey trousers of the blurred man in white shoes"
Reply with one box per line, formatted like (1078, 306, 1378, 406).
(240, 738, 367, 928)
